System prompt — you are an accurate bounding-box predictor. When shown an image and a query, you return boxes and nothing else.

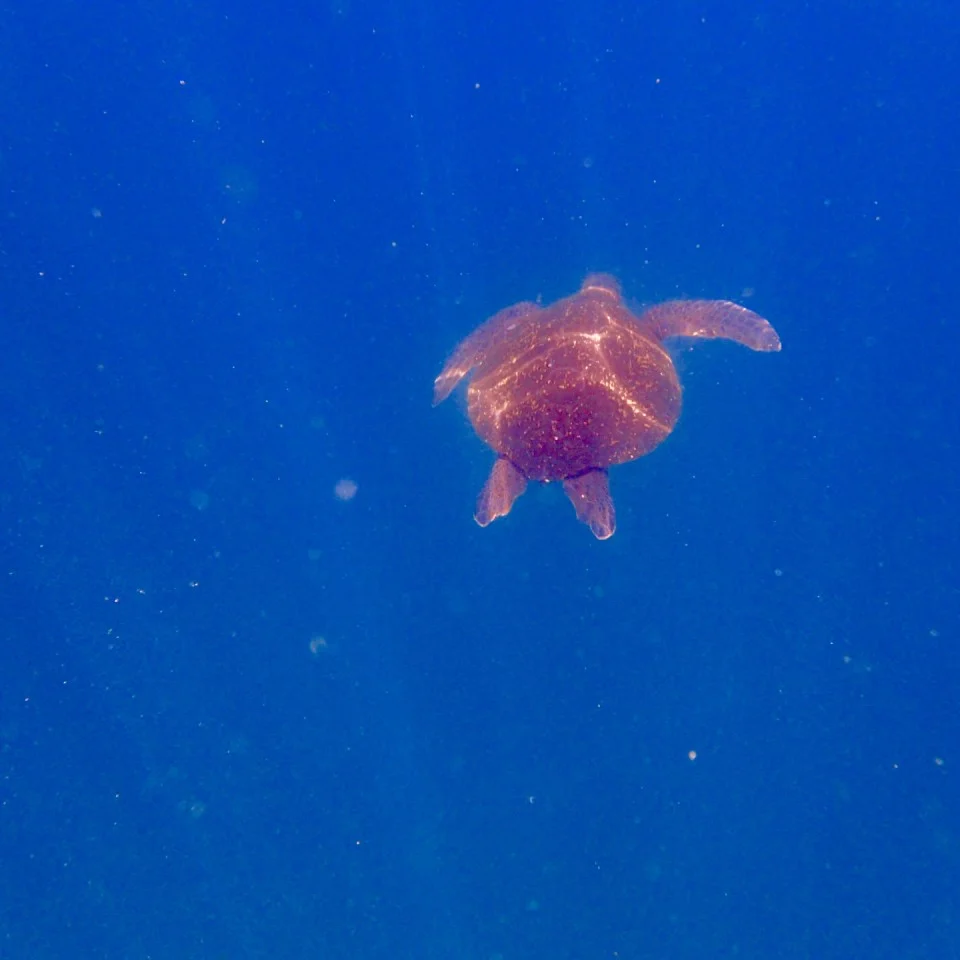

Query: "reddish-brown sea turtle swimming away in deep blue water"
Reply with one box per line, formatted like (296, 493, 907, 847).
(433, 274, 780, 540)
